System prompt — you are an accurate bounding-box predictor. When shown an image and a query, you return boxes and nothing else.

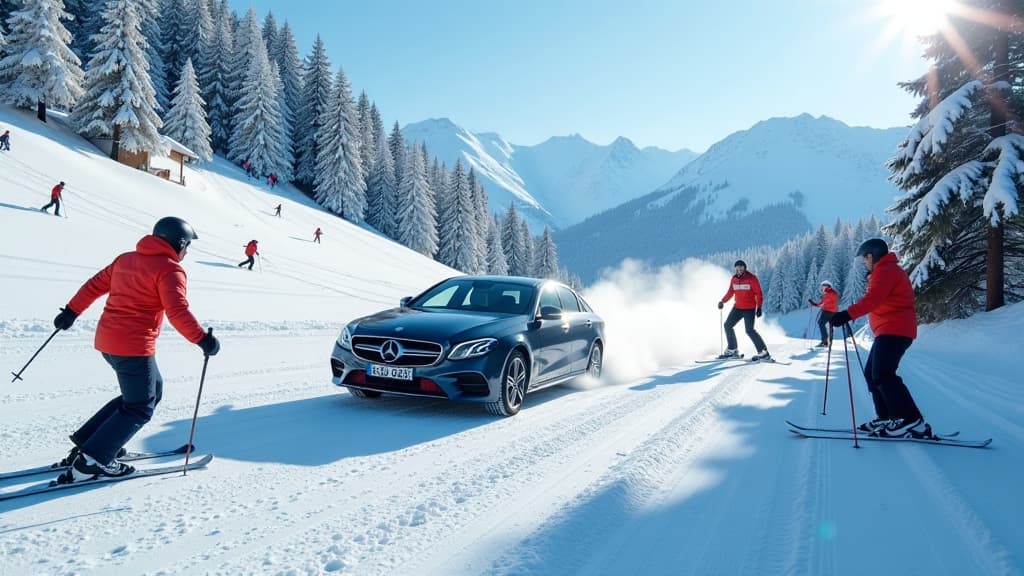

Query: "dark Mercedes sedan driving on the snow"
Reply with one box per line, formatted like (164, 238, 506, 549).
(331, 276, 604, 416)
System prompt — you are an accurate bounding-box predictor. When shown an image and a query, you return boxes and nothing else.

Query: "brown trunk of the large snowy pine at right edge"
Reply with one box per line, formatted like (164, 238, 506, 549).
(985, 5, 1010, 311)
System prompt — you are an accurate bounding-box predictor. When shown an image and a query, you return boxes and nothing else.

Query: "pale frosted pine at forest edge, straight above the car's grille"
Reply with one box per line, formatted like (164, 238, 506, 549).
(396, 140, 437, 257)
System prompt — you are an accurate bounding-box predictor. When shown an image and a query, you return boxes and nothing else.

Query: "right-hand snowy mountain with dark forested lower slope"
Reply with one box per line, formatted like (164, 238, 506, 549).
(556, 114, 907, 280)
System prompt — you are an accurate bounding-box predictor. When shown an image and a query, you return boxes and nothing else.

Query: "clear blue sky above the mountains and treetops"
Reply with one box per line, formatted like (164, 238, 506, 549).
(230, 0, 926, 152)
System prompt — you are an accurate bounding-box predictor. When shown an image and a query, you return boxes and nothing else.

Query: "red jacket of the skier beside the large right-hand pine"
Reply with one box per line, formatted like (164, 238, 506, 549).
(847, 252, 918, 338)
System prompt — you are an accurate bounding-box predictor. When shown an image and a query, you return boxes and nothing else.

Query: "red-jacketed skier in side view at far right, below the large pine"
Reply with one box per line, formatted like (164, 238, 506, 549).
(829, 238, 932, 438)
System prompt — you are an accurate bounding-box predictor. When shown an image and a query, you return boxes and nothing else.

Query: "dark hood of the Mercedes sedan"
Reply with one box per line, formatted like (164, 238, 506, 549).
(353, 308, 524, 342)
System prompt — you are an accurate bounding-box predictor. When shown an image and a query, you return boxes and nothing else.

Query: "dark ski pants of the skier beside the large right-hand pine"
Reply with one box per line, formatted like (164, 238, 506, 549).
(864, 335, 922, 419)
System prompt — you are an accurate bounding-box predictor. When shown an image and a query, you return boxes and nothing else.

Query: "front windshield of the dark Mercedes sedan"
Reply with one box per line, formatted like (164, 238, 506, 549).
(409, 279, 536, 314)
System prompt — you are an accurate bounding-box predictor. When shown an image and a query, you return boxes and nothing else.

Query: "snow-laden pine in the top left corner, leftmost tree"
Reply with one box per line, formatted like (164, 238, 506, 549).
(0, 0, 84, 122)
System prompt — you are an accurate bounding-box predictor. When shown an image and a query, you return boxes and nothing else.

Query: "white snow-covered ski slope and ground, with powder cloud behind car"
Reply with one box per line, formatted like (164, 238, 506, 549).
(0, 108, 1024, 576)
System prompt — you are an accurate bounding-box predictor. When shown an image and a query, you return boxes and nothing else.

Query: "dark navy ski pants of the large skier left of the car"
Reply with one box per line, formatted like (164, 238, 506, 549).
(71, 353, 164, 464)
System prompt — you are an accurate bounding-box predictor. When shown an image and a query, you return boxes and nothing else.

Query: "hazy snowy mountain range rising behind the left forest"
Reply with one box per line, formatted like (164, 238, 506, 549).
(401, 118, 696, 229)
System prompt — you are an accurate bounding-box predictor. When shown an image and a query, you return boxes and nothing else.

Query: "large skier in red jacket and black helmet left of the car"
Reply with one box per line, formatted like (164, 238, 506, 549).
(53, 217, 220, 484)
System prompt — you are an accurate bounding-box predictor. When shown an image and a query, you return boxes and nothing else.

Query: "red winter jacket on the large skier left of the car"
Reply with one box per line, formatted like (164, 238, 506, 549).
(68, 236, 206, 356)
